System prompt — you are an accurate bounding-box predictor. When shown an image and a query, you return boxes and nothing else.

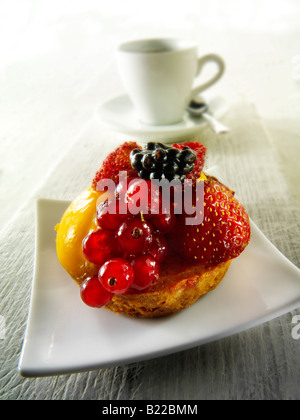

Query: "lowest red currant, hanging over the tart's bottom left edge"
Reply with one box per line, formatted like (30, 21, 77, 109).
(80, 276, 113, 308)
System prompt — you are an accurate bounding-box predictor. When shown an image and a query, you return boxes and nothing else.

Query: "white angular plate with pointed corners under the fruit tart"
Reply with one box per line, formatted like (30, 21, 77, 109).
(18, 199, 300, 377)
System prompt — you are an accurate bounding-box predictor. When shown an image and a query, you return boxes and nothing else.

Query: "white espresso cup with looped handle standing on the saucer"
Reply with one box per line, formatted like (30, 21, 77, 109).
(117, 38, 225, 125)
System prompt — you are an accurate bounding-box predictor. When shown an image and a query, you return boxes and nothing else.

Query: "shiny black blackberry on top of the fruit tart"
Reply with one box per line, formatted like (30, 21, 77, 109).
(130, 142, 197, 182)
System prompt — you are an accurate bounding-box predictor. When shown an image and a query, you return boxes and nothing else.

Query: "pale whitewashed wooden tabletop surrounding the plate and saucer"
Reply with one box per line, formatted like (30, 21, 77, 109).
(0, 0, 300, 399)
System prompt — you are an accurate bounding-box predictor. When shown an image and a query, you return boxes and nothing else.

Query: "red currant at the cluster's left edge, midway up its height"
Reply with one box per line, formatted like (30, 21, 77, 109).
(82, 229, 118, 265)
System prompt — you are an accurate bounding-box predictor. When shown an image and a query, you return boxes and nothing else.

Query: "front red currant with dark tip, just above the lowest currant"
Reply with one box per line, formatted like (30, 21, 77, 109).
(99, 258, 134, 294)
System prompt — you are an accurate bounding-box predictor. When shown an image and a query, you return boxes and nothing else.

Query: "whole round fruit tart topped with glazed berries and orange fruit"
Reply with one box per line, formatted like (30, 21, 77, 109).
(56, 142, 250, 318)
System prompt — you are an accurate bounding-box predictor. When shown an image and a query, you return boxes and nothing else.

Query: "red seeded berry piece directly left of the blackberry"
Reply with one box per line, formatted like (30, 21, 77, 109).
(92, 141, 140, 190)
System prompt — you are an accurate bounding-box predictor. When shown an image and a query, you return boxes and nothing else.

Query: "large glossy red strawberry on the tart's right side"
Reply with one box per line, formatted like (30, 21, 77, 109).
(175, 178, 250, 267)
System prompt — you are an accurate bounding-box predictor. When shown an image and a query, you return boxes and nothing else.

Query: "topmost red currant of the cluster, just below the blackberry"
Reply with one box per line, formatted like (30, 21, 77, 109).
(97, 200, 128, 230)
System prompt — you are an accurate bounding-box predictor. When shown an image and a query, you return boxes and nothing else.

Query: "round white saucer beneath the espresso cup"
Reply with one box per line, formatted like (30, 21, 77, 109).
(96, 94, 227, 143)
